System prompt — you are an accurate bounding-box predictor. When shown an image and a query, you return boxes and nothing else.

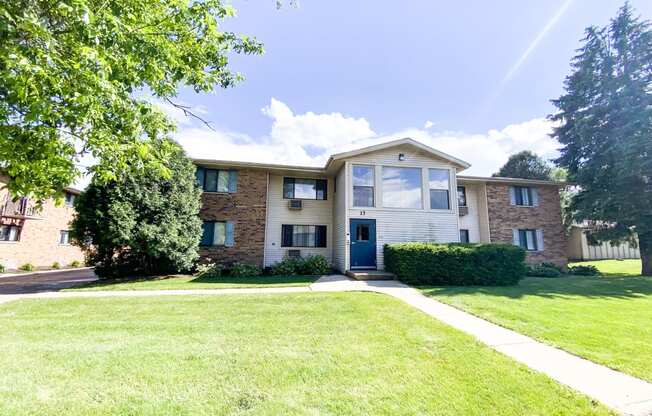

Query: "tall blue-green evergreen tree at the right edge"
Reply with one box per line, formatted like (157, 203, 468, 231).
(550, 3, 652, 275)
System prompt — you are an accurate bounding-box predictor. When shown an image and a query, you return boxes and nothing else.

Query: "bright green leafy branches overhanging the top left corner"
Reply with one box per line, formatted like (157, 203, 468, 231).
(0, 0, 263, 199)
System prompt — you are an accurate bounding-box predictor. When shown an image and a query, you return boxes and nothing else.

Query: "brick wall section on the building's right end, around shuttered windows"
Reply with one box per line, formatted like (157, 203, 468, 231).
(487, 183, 568, 266)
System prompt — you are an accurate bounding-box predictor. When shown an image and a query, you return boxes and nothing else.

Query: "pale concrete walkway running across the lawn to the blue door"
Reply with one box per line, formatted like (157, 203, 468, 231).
(0, 275, 652, 416)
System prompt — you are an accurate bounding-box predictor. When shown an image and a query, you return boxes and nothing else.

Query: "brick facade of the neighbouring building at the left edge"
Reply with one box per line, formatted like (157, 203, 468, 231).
(0, 178, 84, 270)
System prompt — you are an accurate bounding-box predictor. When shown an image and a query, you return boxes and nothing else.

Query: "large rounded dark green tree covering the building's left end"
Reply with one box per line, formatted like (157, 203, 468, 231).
(71, 141, 202, 276)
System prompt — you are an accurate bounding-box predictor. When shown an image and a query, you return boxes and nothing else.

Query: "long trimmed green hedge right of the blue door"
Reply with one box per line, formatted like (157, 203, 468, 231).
(384, 243, 526, 286)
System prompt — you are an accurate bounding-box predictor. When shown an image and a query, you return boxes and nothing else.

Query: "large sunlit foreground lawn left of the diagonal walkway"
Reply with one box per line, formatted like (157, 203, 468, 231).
(0, 293, 609, 415)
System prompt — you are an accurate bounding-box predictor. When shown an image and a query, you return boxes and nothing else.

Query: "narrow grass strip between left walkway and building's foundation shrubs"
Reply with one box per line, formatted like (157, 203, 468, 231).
(65, 275, 318, 291)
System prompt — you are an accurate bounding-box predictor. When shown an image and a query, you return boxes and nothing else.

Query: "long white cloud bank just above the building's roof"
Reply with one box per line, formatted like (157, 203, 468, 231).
(175, 98, 559, 175)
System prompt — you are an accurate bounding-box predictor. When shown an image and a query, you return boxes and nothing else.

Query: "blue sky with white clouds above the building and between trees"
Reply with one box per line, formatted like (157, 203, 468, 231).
(163, 0, 652, 175)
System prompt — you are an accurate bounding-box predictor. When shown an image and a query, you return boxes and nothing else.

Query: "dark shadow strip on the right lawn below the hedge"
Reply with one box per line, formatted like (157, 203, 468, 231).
(419, 275, 652, 299)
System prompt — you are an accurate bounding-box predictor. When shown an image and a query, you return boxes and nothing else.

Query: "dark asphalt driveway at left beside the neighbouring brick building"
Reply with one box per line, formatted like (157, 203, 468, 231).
(0, 269, 97, 295)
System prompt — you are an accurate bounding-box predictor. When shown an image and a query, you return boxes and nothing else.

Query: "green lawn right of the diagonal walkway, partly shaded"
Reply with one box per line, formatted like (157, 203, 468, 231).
(421, 260, 652, 381)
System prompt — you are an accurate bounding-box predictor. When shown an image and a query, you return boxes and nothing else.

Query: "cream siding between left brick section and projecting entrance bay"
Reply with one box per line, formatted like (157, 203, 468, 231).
(265, 174, 332, 266)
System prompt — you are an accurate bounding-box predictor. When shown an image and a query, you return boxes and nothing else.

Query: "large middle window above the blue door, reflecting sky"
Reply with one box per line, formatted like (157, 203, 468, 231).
(383, 166, 422, 209)
